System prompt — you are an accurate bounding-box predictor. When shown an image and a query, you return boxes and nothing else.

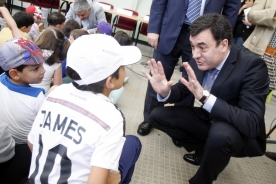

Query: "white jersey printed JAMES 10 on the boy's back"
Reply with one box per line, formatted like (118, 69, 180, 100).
(28, 83, 125, 183)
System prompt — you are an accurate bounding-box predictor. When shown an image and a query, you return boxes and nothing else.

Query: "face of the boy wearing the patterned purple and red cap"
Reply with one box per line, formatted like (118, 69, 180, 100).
(17, 64, 45, 86)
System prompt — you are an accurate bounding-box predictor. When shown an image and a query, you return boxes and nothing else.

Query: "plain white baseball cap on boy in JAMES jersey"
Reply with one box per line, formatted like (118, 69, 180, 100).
(67, 34, 141, 85)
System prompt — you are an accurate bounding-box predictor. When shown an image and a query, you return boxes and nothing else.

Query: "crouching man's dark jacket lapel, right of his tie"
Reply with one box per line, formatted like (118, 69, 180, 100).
(211, 45, 238, 96)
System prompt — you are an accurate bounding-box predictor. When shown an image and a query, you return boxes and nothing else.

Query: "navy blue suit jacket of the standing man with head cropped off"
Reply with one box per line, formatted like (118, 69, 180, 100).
(148, 0, 241, 54)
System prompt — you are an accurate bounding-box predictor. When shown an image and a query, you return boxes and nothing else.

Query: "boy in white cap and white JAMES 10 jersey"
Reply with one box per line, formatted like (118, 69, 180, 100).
(28, 34, 141, 184)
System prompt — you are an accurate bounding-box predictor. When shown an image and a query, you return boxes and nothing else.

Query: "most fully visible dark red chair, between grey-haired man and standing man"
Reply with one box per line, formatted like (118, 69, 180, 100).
(112, 8, 139, 41)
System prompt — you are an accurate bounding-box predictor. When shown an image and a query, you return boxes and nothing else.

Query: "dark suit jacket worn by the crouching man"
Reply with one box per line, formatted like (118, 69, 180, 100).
(166, 45, 269, 156)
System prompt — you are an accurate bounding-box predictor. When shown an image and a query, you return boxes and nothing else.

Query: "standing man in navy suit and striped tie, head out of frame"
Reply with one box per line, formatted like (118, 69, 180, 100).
(137, 0, 241, 135)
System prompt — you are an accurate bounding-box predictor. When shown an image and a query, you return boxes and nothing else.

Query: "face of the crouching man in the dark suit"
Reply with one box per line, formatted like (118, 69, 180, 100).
(190, 29, 229, 71)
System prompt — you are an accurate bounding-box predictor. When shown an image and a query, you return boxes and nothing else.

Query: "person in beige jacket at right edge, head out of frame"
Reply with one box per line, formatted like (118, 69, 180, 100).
(244, 0, 276, 161)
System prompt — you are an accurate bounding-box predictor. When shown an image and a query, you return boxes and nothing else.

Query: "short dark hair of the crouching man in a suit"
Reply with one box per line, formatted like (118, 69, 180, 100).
(190, 13, 232, 46)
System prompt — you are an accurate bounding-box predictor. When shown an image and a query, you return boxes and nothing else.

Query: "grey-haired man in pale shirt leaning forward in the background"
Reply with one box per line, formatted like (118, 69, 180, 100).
(66, 0, 106, 34)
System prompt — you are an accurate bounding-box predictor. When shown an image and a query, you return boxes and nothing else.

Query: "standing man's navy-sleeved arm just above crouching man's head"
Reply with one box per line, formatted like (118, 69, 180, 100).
(222, 0, 241, 28)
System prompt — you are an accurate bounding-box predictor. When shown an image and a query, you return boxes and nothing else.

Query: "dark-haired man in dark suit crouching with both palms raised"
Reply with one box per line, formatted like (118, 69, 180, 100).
(143, 14, 269, 184)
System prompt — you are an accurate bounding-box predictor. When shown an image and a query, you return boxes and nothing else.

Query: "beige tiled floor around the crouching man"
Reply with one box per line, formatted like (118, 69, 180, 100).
(10, 6, 276, 184)
